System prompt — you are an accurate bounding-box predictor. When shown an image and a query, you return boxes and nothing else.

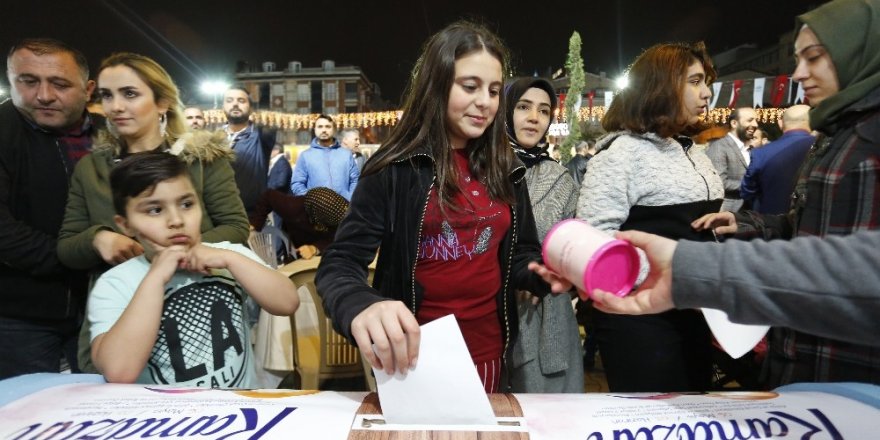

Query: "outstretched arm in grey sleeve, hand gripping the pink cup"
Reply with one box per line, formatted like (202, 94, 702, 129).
(593, 230, 880, 346)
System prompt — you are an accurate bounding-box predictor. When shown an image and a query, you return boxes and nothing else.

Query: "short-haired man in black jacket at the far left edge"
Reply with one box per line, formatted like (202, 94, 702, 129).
(0, 39, 95, 379)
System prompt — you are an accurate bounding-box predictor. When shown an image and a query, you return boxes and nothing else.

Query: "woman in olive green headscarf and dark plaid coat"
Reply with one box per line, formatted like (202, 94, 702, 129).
(694, 0, 880, 386)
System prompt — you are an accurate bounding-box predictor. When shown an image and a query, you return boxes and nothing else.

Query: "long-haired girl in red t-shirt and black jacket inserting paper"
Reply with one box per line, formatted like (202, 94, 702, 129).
(316, 22, 564, 392)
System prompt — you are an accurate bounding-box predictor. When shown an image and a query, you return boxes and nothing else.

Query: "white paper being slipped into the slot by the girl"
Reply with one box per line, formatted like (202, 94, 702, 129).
(373, 315, 497, 425)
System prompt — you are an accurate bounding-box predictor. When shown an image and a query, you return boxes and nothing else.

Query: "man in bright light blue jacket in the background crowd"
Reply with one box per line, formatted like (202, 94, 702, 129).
(290, 115, 361, 201)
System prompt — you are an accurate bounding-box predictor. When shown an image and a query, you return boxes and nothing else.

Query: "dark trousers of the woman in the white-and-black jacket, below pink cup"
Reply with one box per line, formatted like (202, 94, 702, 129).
(593, 310, 712, 392)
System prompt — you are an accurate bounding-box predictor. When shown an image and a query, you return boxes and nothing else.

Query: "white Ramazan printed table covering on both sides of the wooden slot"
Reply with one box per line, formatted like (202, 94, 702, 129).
(0, 374, 880, 440)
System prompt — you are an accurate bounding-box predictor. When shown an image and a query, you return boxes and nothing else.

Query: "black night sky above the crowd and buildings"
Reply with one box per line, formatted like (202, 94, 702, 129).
(0, 0, 824, 104)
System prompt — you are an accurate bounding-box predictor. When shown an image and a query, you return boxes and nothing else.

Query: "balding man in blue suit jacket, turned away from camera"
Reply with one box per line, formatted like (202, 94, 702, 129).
(740, 105, 816, 214)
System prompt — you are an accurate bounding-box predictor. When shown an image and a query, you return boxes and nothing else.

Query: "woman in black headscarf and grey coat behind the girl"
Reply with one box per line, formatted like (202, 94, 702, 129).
(505, 78, 584, 393)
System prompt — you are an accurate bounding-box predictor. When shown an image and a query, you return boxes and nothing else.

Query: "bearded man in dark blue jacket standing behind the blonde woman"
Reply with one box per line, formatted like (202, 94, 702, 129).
(223, 86, 276, 214)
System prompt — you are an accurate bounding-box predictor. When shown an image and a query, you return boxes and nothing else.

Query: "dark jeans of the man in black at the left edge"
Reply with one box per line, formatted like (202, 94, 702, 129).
(0, 316, 79, 379)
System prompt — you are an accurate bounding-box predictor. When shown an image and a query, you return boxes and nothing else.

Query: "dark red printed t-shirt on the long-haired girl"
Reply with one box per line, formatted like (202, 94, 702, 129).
(415, 150, 511, 363)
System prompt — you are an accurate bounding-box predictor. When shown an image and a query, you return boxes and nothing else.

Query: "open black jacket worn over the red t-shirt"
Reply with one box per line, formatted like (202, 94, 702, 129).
(316, 144, 550, 352)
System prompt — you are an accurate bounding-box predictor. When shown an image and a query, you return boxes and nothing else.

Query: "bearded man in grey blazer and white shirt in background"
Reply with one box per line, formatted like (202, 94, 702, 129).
(706, 107, 758, 211)
